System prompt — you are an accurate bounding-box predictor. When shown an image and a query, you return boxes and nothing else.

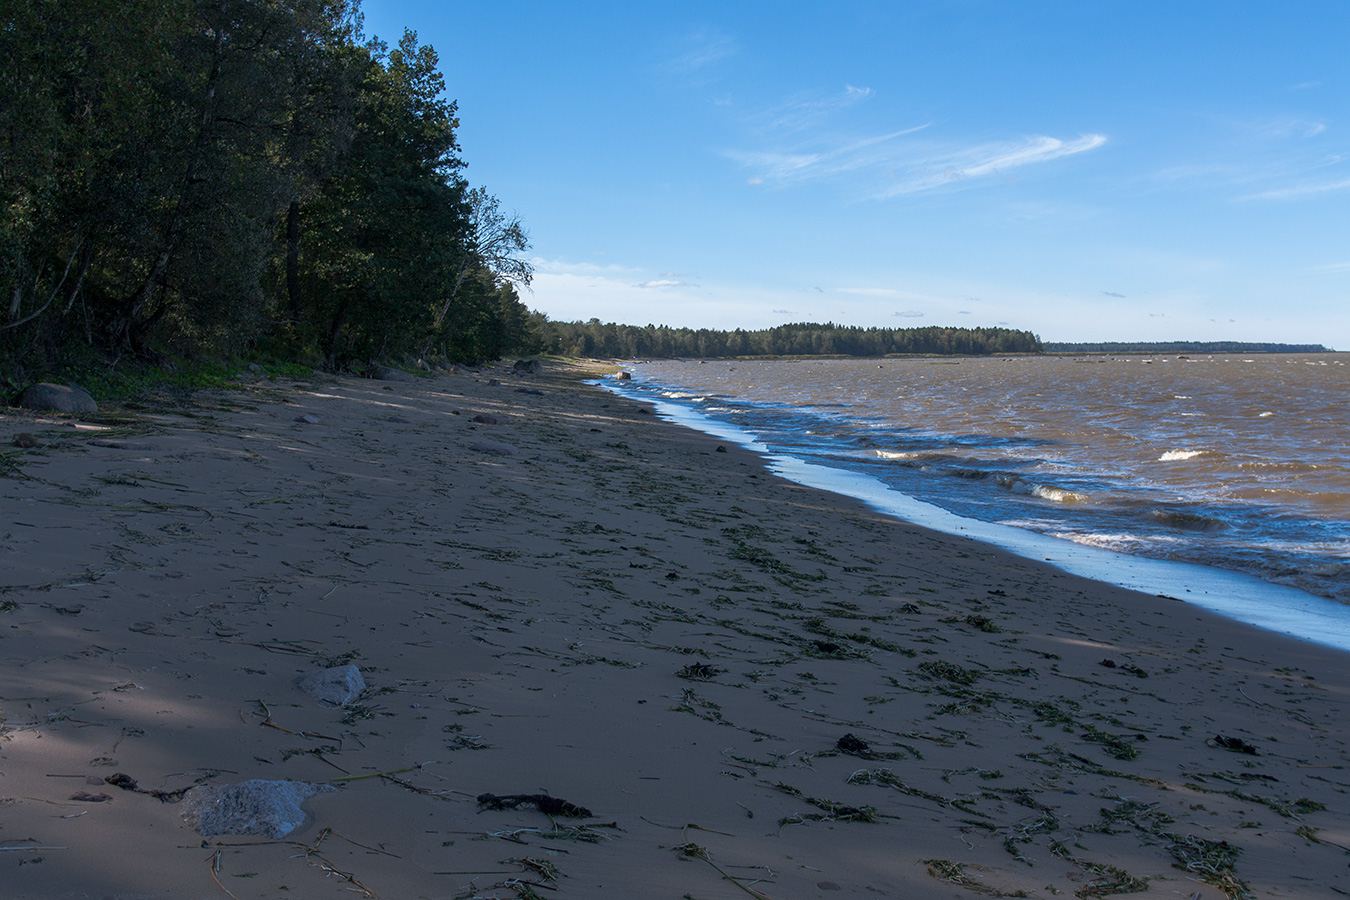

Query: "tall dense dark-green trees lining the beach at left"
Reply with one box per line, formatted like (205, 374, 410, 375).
(0, 0, 531, 376)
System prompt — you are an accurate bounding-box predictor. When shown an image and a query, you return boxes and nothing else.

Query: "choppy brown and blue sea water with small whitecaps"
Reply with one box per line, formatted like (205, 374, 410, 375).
(602, 354, 1350, 649)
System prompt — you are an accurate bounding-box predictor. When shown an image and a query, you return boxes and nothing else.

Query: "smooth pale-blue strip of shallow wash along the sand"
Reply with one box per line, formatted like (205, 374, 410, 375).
(587, 381, 1350, 652)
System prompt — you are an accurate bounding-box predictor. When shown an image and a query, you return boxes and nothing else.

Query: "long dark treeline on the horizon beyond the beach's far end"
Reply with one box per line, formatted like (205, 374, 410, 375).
(535, 317, 1042, 359)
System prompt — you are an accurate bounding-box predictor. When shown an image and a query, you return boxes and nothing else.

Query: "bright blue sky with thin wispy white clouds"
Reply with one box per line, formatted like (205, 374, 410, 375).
(363, 0, 1350, 349)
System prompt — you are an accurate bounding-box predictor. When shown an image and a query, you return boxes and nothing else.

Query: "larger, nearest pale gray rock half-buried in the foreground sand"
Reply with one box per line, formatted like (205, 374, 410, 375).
(182, 779, 338, 841)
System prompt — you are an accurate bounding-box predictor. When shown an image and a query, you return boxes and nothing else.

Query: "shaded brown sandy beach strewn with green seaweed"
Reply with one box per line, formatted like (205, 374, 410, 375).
(0, 364, 1350, 900)
